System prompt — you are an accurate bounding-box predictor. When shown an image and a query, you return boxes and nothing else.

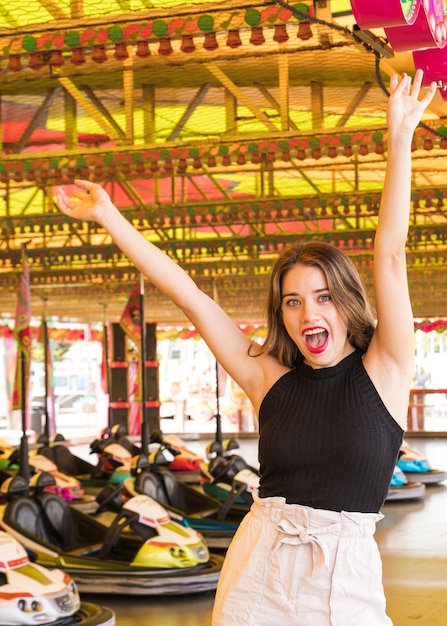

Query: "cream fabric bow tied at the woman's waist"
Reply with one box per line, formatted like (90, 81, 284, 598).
(273, 516, 343, 574)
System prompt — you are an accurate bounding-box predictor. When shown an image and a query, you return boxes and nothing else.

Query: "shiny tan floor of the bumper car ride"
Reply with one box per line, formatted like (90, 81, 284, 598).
(78, 438, 447, 626)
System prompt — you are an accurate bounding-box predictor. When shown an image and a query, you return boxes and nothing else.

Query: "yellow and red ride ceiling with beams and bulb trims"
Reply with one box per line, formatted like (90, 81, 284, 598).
(0, 0, 447, 324)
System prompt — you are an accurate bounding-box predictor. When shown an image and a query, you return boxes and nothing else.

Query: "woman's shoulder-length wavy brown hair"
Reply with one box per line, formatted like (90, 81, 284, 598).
(260, 241, 375, 367)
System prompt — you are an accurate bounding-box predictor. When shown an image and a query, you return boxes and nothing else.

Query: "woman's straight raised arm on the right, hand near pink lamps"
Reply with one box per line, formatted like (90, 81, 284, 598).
(364, 70, 436, 424)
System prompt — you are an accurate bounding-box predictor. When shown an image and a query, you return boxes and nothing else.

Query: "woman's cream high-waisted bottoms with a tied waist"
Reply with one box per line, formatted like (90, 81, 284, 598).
(212, 496, 392, 626)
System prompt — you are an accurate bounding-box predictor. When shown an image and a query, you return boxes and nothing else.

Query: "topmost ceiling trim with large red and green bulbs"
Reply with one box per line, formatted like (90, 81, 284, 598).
(0, 1, 313, 73)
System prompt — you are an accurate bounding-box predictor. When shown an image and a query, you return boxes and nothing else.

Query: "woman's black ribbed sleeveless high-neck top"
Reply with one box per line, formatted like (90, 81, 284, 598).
(259, 351, 403, 513)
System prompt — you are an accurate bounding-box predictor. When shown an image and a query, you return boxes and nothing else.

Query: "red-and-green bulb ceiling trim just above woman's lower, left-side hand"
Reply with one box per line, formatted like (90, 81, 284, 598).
(0, 125, 447, 188)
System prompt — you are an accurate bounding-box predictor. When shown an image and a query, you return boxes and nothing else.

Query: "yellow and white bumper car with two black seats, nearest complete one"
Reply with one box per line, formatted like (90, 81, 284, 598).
(0, 473, 223, 595)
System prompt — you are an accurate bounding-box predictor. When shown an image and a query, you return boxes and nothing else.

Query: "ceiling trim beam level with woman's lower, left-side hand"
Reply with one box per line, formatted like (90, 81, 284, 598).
(0, 187, 447, 232)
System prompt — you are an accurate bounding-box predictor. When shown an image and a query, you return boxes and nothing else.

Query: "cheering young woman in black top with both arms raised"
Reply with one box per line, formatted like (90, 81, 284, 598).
(58, 71, 436, 626)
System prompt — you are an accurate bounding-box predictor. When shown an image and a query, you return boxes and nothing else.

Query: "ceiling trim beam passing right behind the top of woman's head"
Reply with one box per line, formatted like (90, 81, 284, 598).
(0, 223, 447, 274)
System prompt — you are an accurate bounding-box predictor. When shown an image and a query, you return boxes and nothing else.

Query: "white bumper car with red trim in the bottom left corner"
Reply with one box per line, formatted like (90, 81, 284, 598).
(0, 531, 115, 626)
